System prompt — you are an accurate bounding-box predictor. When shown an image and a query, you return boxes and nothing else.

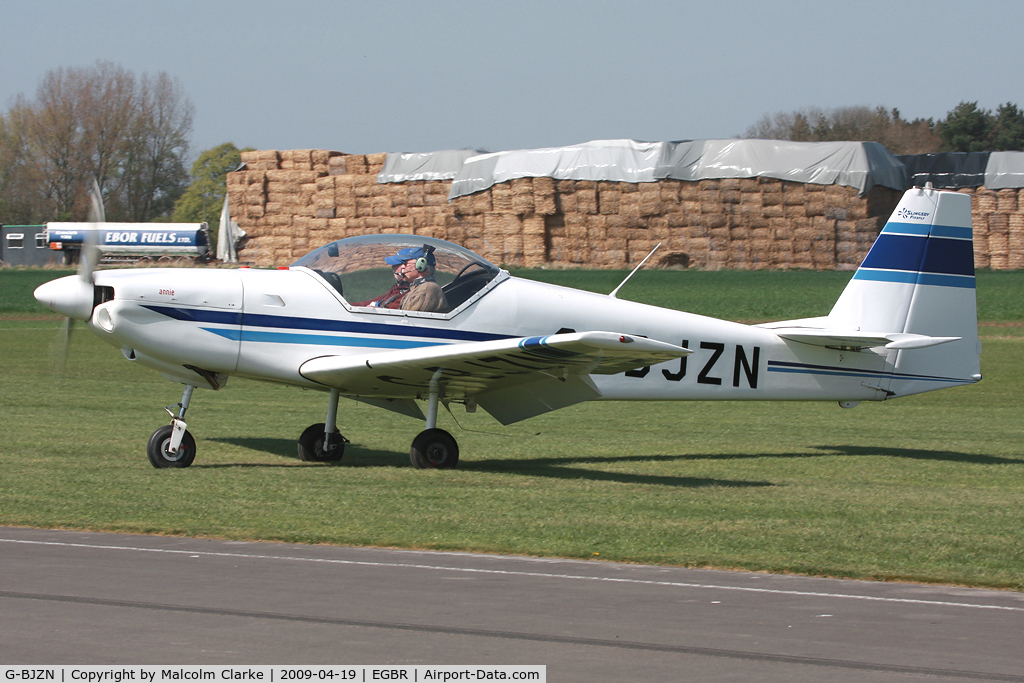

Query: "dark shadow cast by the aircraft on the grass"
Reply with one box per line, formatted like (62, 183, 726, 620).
(201, 438, 775, 487)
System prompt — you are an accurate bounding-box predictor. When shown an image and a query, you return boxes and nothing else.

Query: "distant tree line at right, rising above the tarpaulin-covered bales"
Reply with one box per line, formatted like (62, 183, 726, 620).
(744, 101, 1024, 155)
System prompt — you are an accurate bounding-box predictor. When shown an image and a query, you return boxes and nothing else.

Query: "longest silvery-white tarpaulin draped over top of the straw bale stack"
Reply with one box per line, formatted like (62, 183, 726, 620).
(449, 139, 906, 200)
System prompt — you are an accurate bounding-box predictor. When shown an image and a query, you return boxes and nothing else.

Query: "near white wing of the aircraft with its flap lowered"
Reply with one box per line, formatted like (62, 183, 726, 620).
(299, 332, 692, 424)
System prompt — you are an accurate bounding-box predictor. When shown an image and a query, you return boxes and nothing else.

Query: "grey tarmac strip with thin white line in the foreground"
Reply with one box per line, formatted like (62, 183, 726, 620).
(0, 527, 1024, 682)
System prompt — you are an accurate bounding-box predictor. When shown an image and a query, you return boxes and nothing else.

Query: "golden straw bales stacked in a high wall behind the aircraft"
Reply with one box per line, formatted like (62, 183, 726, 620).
(227, 150, 1024, 269)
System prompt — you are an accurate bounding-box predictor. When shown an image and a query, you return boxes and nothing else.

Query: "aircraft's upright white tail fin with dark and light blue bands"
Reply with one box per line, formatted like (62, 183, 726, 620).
(825, 187, 981, 395)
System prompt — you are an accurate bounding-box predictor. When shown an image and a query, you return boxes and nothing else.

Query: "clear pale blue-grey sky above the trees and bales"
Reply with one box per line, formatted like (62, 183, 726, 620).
(0, 0, 1024, 155)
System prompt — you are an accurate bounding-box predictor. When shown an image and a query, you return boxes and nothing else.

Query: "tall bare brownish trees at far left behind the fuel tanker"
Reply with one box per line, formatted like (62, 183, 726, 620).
(0, 62, 195, 223)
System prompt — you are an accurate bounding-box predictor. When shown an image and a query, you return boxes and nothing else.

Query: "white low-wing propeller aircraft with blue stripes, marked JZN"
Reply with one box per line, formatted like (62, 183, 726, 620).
(35, 187, 981, 468)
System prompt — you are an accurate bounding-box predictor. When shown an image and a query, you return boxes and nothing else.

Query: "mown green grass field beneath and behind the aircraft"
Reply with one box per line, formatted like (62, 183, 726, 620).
(0, 270, 1024, 591)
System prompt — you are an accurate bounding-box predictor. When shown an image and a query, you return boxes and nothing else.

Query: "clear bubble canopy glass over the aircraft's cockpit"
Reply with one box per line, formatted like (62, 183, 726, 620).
(292, 234, 501, 309)
